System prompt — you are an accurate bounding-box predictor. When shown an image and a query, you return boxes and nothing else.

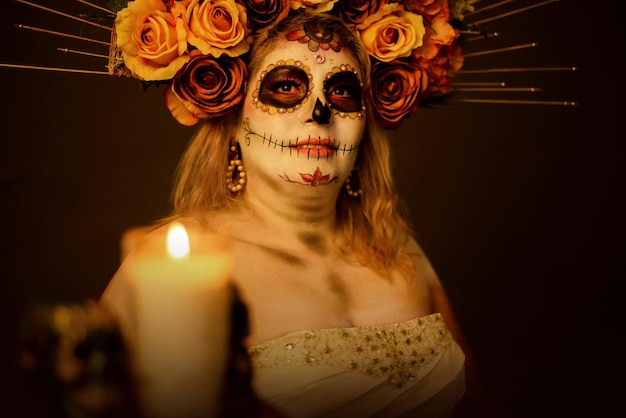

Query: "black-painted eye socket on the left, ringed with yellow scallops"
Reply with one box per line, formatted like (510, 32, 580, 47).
(259, 65, 309, 108)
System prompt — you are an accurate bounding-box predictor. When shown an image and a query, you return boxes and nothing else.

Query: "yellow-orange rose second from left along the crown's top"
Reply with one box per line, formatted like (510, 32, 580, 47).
(187, 0, 252, 58)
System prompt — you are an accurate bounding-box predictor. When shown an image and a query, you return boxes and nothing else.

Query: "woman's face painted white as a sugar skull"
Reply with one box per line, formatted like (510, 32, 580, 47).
(237, 34, 365, 191)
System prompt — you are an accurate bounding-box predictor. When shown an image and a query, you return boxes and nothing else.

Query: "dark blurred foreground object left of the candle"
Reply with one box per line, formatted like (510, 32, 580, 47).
(19, 301, 138, 418)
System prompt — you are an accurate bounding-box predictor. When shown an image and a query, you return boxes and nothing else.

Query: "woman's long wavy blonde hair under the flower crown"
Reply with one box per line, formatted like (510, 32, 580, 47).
(172, 13, 415, 278)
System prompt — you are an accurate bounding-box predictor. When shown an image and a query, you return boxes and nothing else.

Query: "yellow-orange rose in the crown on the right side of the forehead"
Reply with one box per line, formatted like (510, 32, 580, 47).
(357, 3, 426, 62)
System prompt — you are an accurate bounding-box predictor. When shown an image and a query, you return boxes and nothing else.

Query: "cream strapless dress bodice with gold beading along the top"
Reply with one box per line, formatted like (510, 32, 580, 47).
(249, 313, 464, 418)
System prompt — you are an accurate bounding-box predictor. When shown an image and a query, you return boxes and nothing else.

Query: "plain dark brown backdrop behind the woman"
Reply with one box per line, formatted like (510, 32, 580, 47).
(0, 0, 625, 417)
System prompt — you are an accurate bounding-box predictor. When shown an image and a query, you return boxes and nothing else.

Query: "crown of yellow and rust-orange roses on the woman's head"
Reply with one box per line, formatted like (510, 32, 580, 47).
(109, 0, 472, 129)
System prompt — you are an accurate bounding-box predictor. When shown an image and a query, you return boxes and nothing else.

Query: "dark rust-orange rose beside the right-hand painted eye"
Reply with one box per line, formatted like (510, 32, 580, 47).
(371, 61, 427, 129)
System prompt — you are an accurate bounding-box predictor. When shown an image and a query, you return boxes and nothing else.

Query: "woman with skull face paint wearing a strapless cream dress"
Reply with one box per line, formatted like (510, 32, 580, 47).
(102, 3, 488, 418)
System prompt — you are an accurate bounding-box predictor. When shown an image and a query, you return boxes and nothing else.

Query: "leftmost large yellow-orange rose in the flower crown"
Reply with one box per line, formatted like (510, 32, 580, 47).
(115, 0, 189, 81)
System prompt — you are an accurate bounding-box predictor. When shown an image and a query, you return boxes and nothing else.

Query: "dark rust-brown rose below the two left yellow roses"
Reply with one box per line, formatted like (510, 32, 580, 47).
(165, 55, 248, 126)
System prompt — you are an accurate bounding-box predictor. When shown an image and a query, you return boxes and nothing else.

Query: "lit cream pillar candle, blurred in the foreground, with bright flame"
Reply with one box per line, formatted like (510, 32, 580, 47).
(129, 223, 232, 418)
